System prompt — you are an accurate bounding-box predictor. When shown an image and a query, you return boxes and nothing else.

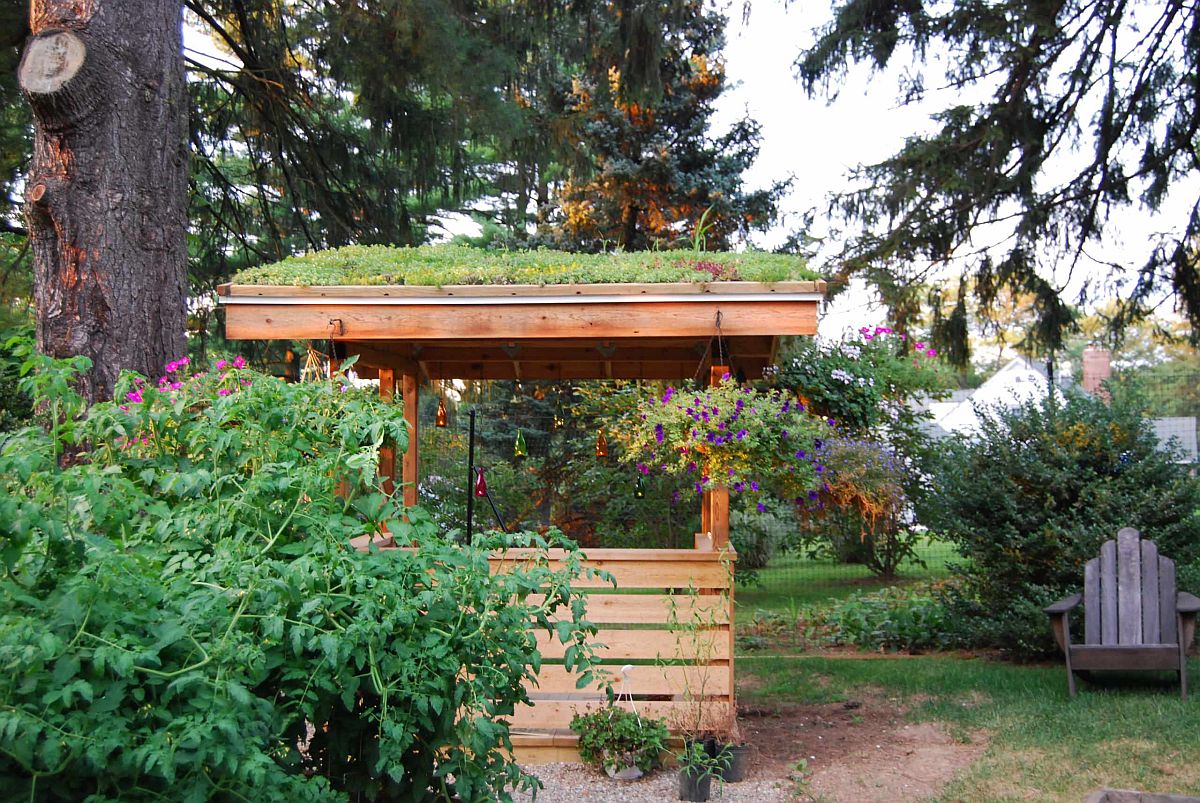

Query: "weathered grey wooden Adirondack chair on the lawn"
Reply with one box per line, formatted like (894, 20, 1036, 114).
(1045, 527, 1200, 697)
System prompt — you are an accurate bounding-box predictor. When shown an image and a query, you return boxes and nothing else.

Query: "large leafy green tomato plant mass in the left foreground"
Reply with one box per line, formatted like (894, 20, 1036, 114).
(0, 348, 594, 801)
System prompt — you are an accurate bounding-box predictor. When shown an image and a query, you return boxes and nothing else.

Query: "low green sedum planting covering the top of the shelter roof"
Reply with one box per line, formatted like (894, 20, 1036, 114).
(226, 245, 817, 287)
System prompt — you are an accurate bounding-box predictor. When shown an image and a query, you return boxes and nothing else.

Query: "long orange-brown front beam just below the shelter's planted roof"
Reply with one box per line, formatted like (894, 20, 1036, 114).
(226, 300, 817, 341)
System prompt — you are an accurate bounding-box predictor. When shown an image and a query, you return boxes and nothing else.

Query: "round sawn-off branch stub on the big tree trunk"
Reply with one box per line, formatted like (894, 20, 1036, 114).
(17, 28, 101, 130)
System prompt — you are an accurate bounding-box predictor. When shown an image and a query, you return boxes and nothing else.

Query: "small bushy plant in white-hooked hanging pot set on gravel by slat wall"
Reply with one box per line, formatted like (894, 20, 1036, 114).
(571, 705, 667, 780)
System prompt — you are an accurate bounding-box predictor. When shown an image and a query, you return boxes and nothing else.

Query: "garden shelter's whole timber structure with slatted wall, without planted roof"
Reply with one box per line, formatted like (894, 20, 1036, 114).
(221, 281, 824, 763)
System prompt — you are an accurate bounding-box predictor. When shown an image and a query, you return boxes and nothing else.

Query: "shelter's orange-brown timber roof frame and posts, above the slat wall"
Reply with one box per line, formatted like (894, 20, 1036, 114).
(220, 281, 824, 546)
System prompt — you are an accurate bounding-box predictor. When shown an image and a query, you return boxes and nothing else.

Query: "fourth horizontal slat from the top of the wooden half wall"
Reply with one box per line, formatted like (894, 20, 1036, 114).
(529, 664, 733, 697)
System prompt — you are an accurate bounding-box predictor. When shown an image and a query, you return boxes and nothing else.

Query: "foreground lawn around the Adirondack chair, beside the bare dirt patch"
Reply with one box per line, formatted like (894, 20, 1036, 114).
(738, 655, 1200, 801)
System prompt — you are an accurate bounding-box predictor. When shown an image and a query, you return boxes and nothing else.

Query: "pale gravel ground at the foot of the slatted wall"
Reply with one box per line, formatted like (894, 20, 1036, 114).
(512, 763, 797, 803)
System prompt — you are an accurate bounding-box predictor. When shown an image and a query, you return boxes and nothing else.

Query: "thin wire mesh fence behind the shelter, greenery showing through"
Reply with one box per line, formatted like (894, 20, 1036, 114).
(420, 383, 954, 609)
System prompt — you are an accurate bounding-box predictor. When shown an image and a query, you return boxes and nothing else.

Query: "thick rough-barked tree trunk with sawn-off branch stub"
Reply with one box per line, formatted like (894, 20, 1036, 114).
(18, 0, 187, 400)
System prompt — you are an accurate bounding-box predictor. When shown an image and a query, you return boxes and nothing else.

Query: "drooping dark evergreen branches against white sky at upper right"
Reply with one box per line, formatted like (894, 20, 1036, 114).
(797, 0, 1200, 362)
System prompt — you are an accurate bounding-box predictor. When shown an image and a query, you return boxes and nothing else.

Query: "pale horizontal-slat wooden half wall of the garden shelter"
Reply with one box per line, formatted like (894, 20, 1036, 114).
(492, 550, 736, 733)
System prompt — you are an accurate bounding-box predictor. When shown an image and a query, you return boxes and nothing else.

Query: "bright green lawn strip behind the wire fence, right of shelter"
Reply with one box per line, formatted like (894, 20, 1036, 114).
(734, 540, 955, 613)
